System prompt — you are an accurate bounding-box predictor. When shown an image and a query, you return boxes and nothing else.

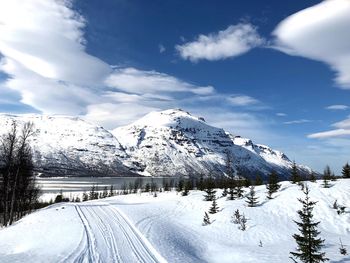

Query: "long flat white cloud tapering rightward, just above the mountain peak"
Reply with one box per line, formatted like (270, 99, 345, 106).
(106, 68, 214, 95)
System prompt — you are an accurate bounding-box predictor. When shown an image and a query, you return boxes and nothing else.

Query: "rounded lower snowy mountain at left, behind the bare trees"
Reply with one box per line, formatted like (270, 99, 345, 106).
(0, 114, 134, 176)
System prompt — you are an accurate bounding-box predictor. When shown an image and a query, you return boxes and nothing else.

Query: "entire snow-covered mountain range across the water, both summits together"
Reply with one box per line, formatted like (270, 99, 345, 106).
(0, 109, 310, 177)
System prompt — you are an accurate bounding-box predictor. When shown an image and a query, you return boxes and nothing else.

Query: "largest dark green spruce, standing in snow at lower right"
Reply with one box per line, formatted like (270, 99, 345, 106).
(290, 186, 328, 263)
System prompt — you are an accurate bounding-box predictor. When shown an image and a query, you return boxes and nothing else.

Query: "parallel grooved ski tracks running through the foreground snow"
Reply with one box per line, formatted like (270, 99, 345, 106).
(61, 204, 166, 263)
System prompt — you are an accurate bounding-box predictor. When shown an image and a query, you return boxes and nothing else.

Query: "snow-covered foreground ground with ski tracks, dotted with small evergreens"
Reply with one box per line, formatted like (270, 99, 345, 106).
(0, 180, 350, 263)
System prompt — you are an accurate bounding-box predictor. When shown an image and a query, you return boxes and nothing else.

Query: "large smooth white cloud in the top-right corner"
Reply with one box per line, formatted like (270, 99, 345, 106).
(273, 0, 350, 89)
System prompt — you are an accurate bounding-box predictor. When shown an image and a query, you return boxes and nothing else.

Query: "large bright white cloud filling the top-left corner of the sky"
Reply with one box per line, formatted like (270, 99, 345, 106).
(0, 0, 110, 84)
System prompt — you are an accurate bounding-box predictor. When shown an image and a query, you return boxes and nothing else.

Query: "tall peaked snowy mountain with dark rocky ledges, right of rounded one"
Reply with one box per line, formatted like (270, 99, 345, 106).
(112, 109, 310, 177)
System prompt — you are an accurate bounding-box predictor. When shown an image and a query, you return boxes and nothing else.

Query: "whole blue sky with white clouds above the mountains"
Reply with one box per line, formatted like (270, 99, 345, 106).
(0, 0, 350, 173)
